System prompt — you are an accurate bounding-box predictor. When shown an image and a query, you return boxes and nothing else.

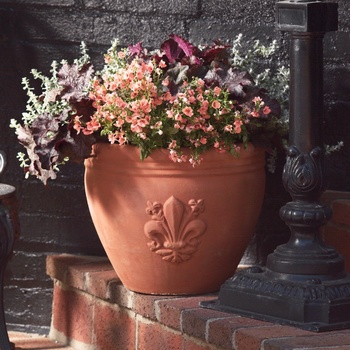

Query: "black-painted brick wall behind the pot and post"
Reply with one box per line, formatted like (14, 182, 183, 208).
(0, 0, 350, 329)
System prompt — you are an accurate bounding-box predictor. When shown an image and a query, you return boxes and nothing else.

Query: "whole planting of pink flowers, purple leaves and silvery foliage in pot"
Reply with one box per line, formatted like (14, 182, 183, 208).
(11, 35, 285, 183)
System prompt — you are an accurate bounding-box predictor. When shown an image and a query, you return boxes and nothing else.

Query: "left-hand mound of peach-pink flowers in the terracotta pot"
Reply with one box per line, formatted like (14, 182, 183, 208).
(74, 57, 164, 145)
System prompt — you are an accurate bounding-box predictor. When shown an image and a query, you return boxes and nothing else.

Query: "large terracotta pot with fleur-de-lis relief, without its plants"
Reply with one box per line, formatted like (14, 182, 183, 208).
(85, 144, 265, 294)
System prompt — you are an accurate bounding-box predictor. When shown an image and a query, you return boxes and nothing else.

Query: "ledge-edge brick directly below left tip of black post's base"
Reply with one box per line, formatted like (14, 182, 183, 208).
(181, 308, 232, 340)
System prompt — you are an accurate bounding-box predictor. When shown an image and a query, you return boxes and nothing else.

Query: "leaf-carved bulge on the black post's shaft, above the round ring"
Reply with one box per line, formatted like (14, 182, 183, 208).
(282, 146, 324, 199)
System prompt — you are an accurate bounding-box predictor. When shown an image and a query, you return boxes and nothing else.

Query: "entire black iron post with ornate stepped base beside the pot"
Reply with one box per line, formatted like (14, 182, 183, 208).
(201, 0, 350, 331)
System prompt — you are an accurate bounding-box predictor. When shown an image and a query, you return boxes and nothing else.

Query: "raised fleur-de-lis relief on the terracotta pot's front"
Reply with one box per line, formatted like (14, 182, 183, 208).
(144, 196, 206, 263)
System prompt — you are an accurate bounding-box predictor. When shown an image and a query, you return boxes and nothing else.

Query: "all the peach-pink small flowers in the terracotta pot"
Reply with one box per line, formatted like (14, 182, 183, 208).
(73, 45, 271, 165)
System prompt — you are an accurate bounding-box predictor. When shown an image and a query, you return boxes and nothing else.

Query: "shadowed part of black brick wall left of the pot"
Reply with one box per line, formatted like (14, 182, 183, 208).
(0, 1, 104, 333)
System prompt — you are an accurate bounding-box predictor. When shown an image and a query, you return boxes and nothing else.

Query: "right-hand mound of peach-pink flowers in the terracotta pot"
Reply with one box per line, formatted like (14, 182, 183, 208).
(163, 79, 264, 165)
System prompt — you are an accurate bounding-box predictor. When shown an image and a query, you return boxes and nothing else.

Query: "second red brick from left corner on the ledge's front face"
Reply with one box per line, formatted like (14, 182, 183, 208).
(94, 301, 136, 350)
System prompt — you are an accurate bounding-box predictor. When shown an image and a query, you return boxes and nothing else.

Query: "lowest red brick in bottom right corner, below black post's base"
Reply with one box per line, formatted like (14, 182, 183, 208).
(262, 330, 350, 350)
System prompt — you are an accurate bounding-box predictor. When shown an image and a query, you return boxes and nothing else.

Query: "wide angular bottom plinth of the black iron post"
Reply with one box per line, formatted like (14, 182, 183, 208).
(201, 267, 350, 332)
